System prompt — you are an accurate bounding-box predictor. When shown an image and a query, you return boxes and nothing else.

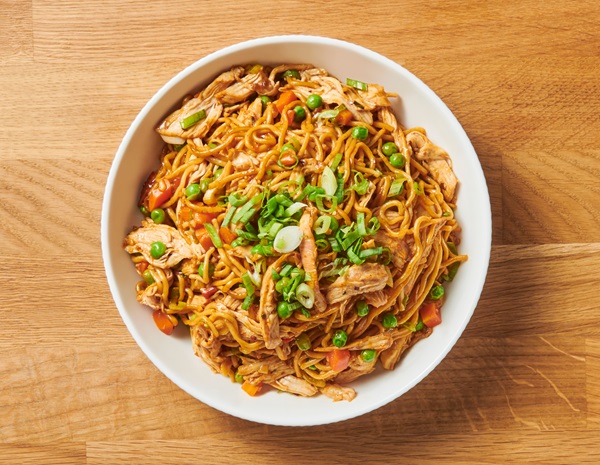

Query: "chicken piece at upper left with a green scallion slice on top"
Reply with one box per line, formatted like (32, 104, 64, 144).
(156, 97, 223, 143)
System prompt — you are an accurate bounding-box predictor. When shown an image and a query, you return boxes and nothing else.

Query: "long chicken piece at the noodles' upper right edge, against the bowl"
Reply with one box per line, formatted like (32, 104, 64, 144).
(406, 131, 458, 202)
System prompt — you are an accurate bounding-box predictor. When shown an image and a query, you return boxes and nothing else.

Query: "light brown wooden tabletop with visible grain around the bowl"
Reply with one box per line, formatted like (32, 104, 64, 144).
(0, 0, 600, 464)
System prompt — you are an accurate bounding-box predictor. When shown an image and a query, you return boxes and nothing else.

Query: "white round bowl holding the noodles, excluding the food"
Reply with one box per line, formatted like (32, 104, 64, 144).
(101, 36, 491, 426)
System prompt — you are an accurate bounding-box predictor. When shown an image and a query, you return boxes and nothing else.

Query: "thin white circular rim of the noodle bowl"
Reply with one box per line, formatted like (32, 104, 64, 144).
(100, 34, 492, 426)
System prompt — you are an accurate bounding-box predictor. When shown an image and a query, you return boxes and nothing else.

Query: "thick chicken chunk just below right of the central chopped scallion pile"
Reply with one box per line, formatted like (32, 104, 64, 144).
(327, 263, 388, 304)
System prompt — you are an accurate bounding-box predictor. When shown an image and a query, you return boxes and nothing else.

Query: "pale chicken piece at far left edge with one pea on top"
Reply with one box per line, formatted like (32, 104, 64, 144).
(124, 221, 202, 268)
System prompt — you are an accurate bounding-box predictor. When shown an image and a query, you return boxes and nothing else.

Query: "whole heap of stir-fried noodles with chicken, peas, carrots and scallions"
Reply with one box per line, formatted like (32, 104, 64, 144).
(125, 65, 467, 400)
